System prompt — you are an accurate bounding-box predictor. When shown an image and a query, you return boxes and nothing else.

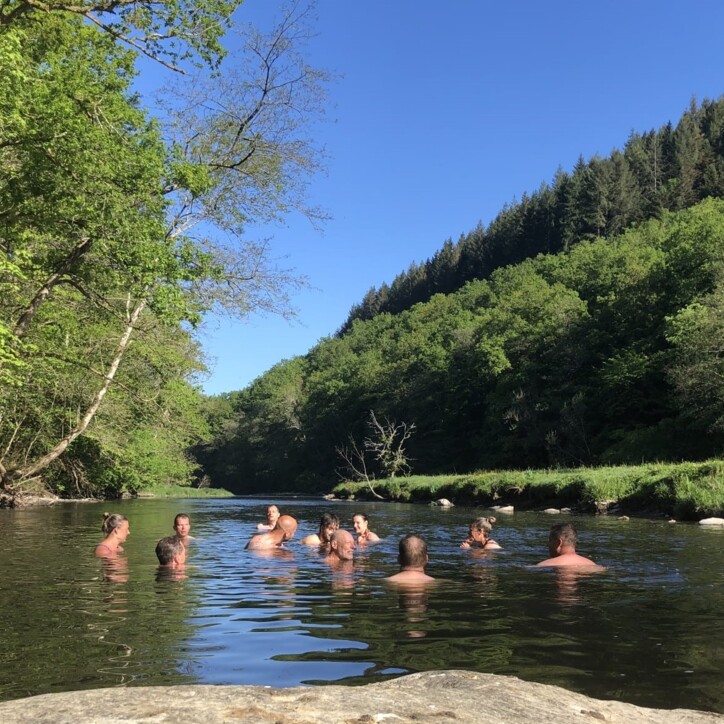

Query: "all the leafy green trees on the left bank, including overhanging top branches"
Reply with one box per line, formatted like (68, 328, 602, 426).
(0, 0, 327, 505)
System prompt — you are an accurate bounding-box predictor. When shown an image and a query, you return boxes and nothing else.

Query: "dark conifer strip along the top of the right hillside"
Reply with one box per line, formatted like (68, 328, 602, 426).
(340, 99, 724, 333)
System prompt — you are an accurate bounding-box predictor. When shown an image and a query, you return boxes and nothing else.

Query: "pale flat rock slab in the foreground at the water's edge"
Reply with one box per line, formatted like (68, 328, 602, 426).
(0, 671, 724, 724)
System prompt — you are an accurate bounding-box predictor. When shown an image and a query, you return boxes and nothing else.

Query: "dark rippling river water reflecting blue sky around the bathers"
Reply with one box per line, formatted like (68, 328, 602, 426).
(0, 498, 724, 713)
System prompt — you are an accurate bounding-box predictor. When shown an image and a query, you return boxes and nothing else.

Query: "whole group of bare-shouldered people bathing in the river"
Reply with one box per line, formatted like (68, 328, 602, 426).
(95, 505, 600, 584)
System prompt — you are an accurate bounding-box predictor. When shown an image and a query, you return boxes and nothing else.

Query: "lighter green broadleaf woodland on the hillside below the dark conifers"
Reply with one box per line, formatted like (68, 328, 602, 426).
(199, 198, 724, 492)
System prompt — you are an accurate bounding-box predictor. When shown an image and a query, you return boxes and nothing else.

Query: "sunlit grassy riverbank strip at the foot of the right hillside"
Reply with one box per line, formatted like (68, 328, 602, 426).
(333, 460, 724, 520)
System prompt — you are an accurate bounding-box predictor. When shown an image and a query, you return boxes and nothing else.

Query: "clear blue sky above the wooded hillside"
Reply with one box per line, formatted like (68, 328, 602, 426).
(178, 0, 724, 394)
